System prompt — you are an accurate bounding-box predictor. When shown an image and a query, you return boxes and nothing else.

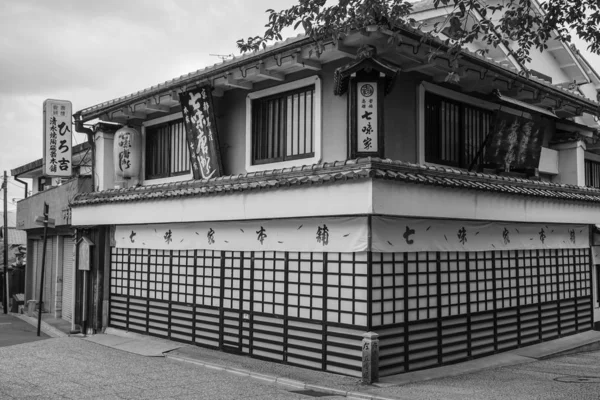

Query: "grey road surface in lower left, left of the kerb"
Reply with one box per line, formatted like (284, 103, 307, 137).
(0, 337, 341, 400)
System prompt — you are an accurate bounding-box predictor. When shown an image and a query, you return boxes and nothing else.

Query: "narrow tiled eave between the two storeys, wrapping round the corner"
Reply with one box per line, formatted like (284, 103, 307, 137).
(72, 157, 600, 207)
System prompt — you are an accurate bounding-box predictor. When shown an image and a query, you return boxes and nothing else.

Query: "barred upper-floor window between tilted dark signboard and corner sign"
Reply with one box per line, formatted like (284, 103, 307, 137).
(252, 85, 315, 165)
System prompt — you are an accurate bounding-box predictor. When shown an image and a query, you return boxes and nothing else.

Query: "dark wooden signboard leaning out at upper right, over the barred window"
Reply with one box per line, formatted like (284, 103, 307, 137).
(485, 111, 546, 171)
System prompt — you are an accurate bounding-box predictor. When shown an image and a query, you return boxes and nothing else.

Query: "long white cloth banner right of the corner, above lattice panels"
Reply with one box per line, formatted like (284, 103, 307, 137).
(372, 217, 590, 253)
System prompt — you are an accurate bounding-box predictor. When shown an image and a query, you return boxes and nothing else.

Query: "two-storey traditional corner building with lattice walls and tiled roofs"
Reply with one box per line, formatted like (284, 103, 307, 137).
(19, 5, 600, 376)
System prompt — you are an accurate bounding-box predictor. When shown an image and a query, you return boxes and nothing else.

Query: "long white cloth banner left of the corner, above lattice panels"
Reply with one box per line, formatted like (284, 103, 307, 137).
(115, 217, 368, 252)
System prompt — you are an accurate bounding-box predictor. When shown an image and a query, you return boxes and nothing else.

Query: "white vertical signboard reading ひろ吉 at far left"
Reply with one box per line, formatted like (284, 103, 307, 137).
(43, 99, 73, 177)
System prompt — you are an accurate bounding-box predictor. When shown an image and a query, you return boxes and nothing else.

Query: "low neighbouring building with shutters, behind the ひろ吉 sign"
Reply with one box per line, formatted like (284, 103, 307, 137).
(11, 142, 92, 322)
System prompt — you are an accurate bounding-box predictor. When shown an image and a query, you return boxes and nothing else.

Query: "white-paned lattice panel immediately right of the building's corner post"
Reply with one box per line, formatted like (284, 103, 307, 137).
(371, 253, 405, 326)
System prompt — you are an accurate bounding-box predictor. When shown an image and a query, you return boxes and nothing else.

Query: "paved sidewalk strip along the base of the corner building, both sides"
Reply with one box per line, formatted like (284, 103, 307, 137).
(15, 318, 600, 400)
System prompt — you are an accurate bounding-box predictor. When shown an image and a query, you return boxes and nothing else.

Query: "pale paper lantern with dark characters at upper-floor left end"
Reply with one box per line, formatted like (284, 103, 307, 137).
(113, 126, 142, 179)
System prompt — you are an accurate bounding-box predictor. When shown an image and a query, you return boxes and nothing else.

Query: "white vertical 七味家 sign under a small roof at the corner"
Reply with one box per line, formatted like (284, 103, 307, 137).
(356, 81, 379, 153)
